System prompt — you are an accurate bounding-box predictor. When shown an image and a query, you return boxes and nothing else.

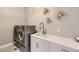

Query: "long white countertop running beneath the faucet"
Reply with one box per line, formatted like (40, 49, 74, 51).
(32, 33, 79, 51)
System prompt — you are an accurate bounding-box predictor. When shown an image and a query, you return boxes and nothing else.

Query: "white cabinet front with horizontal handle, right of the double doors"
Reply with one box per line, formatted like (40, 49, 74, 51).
(48, 42, 72, 52)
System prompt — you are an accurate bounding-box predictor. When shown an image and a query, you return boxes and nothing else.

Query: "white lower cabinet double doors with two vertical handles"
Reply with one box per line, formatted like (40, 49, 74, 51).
(31, 36, 48, 52)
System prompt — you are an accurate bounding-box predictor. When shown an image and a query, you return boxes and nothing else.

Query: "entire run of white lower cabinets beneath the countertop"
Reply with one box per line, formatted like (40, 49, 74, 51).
(31, 35, 79, 52)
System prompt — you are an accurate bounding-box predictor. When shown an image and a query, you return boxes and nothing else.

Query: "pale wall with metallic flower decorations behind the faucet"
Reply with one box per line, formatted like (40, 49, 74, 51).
(26, 7, 79, 38)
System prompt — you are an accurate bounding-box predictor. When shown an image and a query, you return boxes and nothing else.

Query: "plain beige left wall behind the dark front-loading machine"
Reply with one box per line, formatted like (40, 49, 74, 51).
(0, 7, 25, 46)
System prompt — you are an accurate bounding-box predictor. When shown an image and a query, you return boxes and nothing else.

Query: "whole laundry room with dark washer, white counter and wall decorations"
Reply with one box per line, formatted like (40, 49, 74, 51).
(0, 7, 79, 52)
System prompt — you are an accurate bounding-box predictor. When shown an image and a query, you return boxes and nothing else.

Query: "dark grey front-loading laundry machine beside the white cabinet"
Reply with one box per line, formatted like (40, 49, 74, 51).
(13, 25, 36, 52)
